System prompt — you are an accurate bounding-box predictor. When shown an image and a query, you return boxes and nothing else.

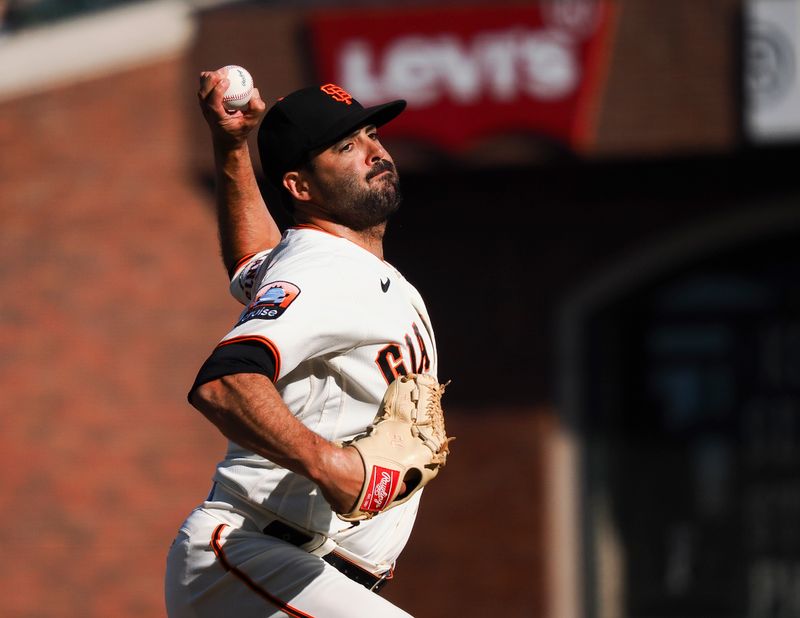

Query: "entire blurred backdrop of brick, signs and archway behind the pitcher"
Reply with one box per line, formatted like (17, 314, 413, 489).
(0, 0, 800, 618)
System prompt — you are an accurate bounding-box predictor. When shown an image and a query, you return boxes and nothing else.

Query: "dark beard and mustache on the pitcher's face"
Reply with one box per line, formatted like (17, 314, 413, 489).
(312, 159, 403, 232)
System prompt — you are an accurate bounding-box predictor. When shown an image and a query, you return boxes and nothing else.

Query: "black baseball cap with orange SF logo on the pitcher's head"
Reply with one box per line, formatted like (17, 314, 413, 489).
(258, 84, 406, 210)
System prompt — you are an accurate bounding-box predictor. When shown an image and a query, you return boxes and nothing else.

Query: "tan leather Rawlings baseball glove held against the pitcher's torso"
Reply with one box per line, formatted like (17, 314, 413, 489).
(338, 374, 455, 521)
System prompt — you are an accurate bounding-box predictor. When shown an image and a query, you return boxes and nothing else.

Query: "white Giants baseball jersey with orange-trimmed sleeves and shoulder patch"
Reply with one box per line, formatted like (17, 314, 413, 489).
(214, 226, 437, 568)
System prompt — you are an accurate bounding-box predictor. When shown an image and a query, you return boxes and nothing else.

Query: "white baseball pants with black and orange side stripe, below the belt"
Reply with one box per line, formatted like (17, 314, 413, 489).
(165, 508, 410, 618)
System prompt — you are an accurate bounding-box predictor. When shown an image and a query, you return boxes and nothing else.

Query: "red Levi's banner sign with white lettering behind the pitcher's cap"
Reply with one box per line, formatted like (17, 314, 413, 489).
(309, 0, 614, 151)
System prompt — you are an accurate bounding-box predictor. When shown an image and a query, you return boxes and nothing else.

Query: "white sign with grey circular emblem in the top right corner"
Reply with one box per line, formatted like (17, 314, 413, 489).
(743, 0, 800, 143)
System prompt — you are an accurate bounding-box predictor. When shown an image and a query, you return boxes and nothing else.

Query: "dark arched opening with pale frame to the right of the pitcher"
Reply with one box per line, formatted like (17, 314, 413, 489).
(561, 203, 800, 617)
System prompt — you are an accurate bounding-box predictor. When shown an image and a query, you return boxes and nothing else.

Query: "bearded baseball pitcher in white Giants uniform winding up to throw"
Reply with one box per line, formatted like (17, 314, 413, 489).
(165, 71, 448, 618)
